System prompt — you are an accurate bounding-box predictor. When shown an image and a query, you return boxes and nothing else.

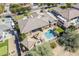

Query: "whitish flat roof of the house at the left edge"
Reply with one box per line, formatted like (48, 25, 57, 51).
(0, 18, 13, 31)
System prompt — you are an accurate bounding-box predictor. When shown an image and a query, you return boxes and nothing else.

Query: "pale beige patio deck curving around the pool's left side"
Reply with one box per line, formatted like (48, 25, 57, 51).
(27, 27, 56, 42)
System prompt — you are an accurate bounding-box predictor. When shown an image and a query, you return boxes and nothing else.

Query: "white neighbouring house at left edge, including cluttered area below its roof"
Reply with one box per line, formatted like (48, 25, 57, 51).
(0, 18, 14, 41)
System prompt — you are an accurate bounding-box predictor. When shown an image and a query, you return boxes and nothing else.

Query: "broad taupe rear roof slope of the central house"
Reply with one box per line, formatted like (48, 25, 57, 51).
(18, 11, 54, 33)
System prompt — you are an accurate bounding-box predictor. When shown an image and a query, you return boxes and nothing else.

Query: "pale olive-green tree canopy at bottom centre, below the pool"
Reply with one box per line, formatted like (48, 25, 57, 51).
(26, 43, 53, 56)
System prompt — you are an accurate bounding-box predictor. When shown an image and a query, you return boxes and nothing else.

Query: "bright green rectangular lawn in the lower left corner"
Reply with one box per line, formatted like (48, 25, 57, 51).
(0, 40, 8, 56)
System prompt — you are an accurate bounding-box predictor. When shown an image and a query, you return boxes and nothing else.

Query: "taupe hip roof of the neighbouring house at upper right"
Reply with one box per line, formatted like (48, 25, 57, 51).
(54, 8, 79, 21)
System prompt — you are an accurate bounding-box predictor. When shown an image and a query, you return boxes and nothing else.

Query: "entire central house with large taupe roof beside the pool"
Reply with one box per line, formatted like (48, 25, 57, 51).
(18, 11, 56, 33)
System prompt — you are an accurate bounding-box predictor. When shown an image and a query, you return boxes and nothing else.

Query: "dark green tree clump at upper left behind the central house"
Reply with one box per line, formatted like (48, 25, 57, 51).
(10, 4, 31, 14)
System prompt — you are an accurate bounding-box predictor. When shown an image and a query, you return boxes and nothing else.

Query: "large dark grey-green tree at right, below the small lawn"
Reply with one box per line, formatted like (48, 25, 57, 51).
(58, 29, 79, 52)
